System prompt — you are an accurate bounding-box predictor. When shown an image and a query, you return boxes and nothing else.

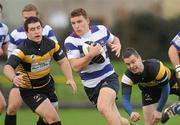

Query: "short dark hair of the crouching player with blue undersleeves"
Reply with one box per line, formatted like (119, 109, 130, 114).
(122, 47, 140, 59)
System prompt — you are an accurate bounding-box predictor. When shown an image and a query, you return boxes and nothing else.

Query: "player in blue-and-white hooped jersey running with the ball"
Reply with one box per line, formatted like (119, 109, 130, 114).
(64, 8, 129, 125)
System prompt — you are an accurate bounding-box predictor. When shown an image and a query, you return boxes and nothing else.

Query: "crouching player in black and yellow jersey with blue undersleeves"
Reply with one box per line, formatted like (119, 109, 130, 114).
(121, 48, 180, 125)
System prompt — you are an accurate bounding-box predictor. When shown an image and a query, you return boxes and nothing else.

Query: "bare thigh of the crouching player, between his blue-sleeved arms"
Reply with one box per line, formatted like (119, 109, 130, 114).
(143, 103, 157, 125)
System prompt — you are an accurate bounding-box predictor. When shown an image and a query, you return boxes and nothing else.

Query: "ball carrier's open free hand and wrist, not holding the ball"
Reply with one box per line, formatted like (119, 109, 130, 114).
(109, 36, 121, 57)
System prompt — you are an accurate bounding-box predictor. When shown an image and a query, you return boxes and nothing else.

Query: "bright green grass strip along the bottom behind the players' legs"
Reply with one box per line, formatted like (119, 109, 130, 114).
(0, 109, 179, 125)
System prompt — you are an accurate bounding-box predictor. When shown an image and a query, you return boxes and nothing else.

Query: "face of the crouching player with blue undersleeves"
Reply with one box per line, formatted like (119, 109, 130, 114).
(124, 55, 144, 74)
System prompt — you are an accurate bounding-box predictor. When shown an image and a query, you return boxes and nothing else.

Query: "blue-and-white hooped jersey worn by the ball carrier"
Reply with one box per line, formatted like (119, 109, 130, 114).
(64, 25, 115, 88)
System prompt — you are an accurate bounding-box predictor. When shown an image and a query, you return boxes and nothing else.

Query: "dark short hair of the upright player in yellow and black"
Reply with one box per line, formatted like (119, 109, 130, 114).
(24, 17, 43, 32)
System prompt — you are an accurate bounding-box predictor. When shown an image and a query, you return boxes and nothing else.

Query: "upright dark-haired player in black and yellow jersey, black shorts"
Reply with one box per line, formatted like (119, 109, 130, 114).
(4, 17, 77, 125)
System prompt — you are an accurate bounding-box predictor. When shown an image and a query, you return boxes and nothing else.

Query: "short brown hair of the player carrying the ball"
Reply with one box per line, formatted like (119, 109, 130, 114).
(71, 8, 89, 19)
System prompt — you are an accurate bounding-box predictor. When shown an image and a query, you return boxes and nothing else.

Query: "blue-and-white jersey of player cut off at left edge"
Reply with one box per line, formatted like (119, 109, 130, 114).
(0, 22, 9, 47)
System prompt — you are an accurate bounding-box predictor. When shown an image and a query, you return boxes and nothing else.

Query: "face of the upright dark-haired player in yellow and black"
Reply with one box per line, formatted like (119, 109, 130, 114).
(26, 22, 42, 43)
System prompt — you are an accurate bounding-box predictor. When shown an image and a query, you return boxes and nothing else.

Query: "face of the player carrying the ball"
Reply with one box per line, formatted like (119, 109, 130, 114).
(71, 15, 89, 36)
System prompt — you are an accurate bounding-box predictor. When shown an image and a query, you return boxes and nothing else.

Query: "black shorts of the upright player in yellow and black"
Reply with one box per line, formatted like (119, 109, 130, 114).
(20, 79, 58, 111)
